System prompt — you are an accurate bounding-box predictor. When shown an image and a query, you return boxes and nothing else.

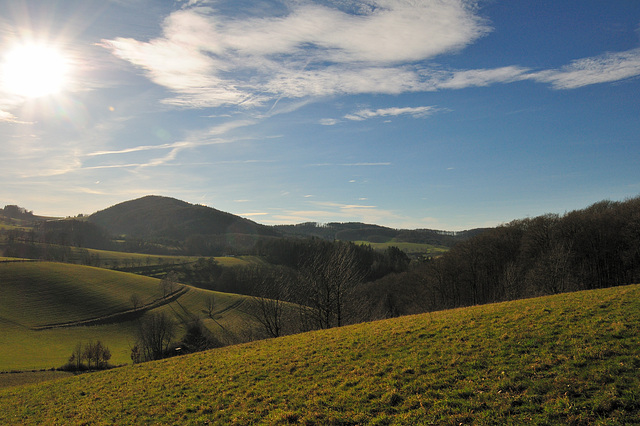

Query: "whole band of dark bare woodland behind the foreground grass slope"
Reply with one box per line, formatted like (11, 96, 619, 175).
(170, 197, 640, 336)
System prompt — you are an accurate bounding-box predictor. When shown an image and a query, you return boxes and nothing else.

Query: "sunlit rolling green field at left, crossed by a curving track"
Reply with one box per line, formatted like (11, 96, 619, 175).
(0, 261, 266, 371)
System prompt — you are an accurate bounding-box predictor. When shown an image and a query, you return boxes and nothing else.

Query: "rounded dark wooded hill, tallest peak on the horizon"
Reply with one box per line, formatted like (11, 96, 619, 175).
(89, 195, 279, 241)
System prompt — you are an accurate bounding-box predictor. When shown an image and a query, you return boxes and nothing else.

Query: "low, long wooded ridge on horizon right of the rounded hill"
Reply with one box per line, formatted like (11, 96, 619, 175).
(274, 222, 487, 247)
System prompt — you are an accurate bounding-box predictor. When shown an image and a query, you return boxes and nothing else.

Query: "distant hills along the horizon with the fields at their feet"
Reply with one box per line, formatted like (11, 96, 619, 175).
(0, 195, 485, 260)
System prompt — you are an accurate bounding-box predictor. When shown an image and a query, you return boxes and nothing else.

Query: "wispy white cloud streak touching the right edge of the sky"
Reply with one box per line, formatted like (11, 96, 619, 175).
(530, 49, 640, 89)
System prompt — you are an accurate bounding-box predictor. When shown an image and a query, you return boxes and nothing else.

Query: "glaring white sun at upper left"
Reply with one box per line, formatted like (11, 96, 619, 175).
(1, 44, 69, 98)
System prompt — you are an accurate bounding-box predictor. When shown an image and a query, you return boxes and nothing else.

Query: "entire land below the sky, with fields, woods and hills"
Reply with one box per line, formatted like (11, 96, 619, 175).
(0, 198, 640, 424)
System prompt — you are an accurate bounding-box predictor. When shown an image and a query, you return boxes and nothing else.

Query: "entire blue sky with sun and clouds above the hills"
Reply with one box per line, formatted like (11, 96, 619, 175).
(0, 0, 640, 230)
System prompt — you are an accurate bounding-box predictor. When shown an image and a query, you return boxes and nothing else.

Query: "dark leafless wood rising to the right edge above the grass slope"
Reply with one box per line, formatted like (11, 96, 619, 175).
(352, 197, 640, 319)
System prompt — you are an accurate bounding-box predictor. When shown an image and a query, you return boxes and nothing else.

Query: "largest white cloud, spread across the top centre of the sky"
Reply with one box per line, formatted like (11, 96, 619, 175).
(102, 0, 489, 108)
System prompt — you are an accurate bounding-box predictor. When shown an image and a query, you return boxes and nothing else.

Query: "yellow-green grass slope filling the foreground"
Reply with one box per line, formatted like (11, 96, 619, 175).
(0, 285, 640, 424)
